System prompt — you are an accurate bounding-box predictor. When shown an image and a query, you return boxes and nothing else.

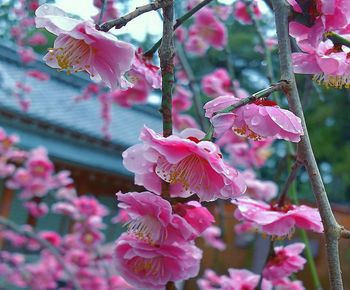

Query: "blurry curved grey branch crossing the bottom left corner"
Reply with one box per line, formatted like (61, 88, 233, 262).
(0, 217, 81, 290)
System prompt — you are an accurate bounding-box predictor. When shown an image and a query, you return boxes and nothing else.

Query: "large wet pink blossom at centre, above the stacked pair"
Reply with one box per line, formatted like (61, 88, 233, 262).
(123, 128, 246, 201)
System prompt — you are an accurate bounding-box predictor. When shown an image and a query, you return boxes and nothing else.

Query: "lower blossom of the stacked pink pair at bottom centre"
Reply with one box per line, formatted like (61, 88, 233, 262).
(114, 234, 202, 290)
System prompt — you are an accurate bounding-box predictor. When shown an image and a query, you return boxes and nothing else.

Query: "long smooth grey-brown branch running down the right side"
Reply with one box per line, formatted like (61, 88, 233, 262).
(272, 0, 343, 290)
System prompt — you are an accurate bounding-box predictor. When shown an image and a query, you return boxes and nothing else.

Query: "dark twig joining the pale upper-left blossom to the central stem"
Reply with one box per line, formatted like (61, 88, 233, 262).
(96, 0, 172, 32)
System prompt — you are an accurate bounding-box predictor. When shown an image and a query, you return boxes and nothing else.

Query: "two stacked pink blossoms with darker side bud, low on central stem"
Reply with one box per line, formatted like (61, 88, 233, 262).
(115, 191, 214, 289)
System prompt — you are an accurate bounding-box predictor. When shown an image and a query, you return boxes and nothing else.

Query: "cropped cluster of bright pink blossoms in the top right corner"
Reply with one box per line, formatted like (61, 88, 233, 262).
(288, 0, 350, 88)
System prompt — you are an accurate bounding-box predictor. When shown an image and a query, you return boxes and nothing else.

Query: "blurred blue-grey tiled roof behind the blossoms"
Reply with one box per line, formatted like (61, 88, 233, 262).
(0, 44, 161, 171)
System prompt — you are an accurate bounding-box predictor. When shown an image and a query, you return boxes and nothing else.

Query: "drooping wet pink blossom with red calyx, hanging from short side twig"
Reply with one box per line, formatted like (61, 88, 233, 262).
(204, 96, 304, 142)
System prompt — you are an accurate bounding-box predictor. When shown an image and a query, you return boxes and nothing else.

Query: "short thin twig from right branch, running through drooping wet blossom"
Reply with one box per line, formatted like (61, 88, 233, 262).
(202, 81, 285, 141)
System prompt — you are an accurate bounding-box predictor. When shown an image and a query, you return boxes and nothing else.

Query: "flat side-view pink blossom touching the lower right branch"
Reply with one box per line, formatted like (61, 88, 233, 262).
(232, 198, 323, 237)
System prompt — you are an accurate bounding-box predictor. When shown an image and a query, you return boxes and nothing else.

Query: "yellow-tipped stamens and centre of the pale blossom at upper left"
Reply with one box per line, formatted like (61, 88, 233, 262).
(48, 36, 93, 74)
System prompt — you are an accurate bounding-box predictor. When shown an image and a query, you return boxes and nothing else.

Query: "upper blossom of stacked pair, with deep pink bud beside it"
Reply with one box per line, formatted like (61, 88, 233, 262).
(117, 191, 214, 244)
